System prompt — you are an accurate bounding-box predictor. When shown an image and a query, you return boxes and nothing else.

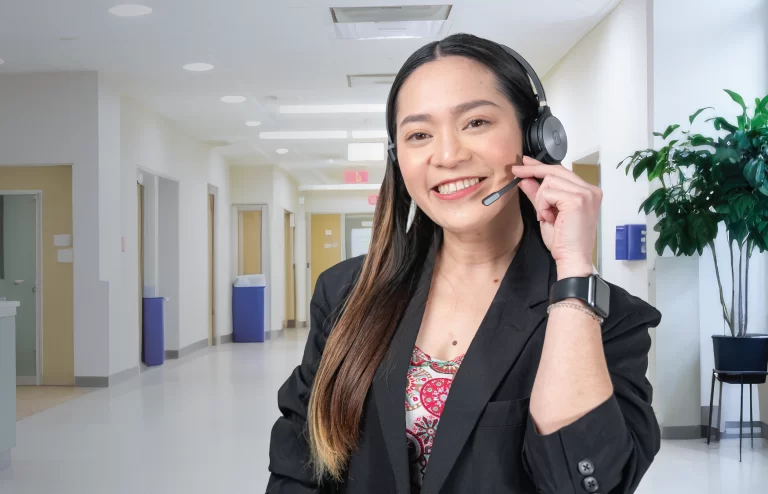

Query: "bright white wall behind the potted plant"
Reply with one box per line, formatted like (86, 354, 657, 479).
(653, 0, 768, 428)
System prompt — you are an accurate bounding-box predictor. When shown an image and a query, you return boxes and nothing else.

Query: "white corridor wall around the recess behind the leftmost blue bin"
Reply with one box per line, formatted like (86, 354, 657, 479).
(121, 97, 234, 358)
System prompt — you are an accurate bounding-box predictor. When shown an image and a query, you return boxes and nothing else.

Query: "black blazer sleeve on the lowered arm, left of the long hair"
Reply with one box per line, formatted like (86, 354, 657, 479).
(266, 275, 332, 494)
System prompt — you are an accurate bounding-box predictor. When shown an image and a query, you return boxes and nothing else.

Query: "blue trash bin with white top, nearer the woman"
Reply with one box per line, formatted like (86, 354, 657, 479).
(232, 274, 267, 343)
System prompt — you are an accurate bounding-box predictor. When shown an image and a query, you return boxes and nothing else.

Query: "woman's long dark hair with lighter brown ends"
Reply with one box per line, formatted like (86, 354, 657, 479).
(308, 34, 538, 479)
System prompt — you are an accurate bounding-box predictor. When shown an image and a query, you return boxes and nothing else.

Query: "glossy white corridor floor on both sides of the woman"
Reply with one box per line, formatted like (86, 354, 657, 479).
(0, 330, 768, 494)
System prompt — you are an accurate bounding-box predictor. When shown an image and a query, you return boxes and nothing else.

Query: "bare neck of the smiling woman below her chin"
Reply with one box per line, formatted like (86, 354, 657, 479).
(438, 197, 524, 279)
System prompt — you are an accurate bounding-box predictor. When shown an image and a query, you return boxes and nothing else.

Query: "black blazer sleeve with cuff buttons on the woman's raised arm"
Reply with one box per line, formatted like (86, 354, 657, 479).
(523, 301, 661, 494)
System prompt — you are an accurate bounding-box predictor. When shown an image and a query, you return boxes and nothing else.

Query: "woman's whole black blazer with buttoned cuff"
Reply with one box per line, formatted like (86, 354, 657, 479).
(267, 228, 661, 494)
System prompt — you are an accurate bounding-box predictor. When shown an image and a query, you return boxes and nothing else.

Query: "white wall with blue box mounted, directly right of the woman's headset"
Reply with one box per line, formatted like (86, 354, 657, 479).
(543, 0, 649, 300)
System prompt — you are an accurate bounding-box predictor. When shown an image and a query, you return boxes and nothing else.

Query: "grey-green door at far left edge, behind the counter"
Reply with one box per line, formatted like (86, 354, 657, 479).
(0, 194, 38, 384)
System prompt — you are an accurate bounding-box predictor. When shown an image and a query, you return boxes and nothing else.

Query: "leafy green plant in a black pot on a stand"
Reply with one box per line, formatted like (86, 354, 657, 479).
(619, 89, 768, 383)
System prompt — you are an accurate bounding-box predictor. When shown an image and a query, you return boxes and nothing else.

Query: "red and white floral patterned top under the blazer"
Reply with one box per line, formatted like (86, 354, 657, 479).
(405, 347, 464, 494)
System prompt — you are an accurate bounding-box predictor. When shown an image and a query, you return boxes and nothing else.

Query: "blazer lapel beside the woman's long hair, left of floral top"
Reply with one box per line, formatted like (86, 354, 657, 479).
(373, 246, 439, 494)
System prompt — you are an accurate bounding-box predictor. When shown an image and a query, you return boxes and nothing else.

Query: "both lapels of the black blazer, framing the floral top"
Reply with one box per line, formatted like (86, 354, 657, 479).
(373, 221, 555, 494)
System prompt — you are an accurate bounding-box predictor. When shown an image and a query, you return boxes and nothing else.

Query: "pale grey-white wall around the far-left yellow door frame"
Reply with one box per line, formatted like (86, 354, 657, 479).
(0, 72, 109, 376)
